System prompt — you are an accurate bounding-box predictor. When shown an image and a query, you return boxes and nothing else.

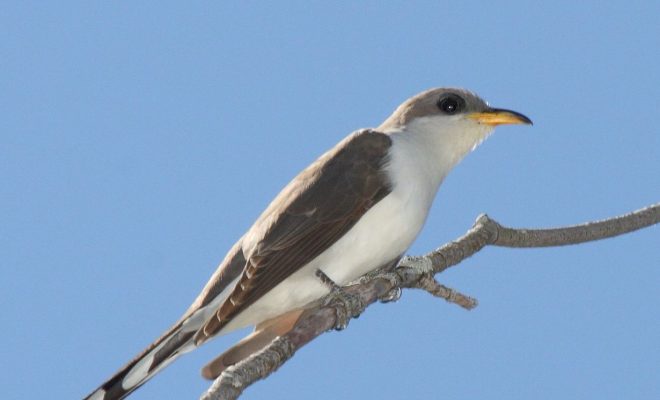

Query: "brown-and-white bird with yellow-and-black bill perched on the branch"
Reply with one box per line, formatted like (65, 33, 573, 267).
(85, 88, 532, 400)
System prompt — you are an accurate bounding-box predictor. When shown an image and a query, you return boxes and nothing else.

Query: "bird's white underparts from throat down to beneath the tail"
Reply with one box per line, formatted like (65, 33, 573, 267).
(205, 116, 492, 333)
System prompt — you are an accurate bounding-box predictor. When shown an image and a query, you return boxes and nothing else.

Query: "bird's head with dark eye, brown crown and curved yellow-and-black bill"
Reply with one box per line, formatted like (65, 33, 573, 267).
(378, 88, 532, 165)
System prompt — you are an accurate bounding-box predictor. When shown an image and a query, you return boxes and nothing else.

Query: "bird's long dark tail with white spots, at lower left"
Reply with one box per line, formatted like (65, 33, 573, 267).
(84, 321, 195, 400)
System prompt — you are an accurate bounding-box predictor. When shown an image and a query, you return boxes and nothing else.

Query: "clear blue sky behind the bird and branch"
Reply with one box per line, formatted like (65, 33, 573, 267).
(0, 1, 660, 400)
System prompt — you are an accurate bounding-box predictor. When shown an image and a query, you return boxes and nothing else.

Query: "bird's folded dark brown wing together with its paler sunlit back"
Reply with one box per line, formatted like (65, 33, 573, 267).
(195, 130, 392, 343)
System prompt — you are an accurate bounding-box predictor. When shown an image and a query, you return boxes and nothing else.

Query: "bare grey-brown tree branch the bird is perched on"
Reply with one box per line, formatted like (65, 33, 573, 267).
(201, 203, 660, 400)
